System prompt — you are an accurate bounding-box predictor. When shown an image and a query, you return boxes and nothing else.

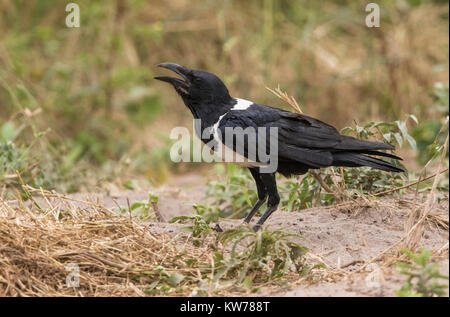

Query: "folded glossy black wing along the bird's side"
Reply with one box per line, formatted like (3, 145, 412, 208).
(218, 104, 400, 168)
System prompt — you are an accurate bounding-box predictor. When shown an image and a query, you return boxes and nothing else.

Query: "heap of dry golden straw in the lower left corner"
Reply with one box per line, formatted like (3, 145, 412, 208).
(0, 190, 212, 296)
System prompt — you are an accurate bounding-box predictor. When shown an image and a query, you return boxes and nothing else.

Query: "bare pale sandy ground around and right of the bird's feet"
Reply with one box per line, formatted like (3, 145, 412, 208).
(64, 175, 449, 296)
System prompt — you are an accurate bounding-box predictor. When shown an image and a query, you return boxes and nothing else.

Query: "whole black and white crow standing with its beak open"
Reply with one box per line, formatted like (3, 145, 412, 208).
(155, 63, 403, 230)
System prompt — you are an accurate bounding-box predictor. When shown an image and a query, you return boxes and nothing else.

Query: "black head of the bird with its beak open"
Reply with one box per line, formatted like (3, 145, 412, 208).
(155, 63, 231, 104)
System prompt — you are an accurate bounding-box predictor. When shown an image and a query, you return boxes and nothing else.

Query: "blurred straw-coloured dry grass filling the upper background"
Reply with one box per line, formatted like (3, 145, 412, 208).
(0, 0, 448, 144)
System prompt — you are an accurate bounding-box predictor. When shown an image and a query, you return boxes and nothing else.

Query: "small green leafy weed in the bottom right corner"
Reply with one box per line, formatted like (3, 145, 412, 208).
(396, 249, 448, 297)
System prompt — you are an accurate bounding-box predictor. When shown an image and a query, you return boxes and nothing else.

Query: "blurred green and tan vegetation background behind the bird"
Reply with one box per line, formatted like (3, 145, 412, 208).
(0, 0, 449, 192)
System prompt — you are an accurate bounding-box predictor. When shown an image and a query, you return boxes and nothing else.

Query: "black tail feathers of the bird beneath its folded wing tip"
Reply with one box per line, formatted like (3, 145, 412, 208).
(333, 152, 404, 172)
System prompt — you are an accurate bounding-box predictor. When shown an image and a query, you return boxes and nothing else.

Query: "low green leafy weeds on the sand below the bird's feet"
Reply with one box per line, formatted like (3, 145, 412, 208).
(170, 214, 312, 292)
